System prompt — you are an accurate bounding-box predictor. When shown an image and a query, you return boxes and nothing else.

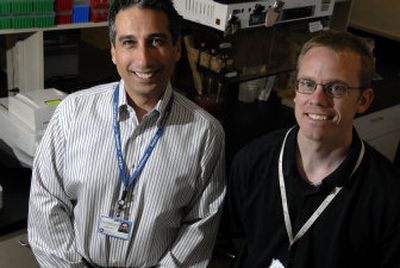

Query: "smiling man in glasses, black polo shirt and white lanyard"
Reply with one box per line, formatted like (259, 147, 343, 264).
(223, 31, 400, 268)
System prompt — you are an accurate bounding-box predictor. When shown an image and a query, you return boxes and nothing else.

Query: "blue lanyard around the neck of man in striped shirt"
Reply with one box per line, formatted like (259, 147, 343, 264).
(113, 84, 174, 209)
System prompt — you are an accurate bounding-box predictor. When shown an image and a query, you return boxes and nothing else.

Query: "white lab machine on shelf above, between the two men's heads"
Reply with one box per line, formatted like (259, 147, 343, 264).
(174, 0, 335, 32)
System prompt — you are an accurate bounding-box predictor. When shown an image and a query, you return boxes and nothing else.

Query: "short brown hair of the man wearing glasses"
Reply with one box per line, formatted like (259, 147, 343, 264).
(297, 30, 375, 88)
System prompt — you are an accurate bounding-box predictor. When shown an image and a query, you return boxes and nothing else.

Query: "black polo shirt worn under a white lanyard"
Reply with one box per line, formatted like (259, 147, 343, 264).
(222, 128, 400, 268)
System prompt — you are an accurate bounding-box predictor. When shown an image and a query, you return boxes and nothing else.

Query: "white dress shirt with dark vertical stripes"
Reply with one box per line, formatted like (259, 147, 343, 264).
(28, 80, 226, 268)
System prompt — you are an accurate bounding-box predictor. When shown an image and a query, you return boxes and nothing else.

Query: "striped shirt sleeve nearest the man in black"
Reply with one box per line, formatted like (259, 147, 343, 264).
(157, 125, 226, 268)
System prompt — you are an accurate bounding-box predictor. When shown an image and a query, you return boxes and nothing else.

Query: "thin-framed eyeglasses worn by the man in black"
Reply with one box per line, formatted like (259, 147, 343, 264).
(296, 79, 365, 98)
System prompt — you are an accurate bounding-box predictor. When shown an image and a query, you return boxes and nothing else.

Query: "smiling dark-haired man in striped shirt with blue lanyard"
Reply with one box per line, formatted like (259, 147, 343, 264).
(28, 0, 225, 267)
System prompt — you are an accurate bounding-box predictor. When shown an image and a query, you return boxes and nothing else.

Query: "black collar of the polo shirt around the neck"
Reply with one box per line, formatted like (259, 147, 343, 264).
(283, 126, 361, 189)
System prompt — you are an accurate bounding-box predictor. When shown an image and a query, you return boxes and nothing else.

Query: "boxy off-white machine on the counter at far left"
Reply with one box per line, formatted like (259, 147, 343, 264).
(0, 88, 66, 167)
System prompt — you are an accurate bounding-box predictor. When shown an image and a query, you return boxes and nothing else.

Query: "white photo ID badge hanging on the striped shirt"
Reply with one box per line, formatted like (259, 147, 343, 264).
(97, 216, 133, 240)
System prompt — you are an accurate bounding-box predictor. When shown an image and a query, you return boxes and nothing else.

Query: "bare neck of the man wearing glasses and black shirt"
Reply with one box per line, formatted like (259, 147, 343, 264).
(296, 135, 351, 185)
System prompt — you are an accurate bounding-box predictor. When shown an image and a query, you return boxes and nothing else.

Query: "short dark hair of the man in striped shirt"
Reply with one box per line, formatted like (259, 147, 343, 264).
(108, 0, 182, 45)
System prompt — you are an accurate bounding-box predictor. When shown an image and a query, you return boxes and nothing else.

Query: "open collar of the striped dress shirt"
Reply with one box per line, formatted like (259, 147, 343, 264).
(118, 79, 173, 125)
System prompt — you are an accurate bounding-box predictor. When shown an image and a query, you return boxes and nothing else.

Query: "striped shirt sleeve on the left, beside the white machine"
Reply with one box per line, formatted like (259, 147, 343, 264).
(28, 107, 84, 268)
